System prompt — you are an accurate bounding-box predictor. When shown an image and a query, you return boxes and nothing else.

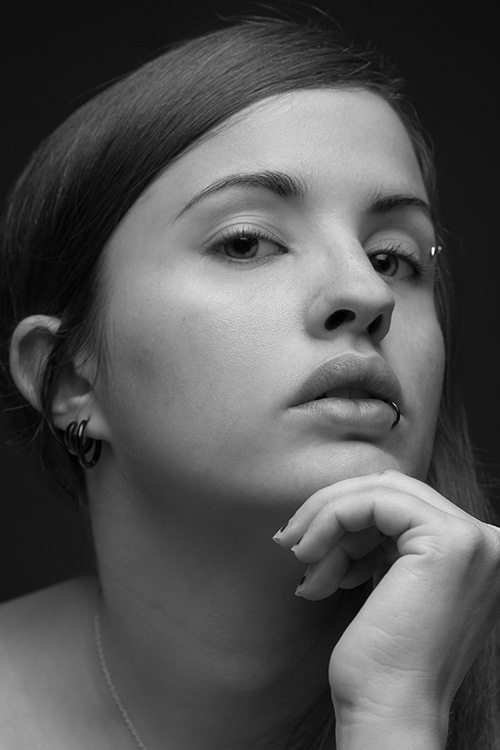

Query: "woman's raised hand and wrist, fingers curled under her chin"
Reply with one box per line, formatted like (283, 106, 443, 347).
(275, 471, 500, 750)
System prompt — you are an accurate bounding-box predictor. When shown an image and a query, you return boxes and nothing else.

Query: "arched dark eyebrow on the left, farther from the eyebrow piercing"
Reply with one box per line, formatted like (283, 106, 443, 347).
(174, 170, 306, 221)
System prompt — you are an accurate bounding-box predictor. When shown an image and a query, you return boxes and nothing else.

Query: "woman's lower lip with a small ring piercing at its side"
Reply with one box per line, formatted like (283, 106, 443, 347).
(295, 398, 396, 438)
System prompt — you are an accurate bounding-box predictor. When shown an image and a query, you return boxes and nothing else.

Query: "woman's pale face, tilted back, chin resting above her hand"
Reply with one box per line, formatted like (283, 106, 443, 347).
(97, 90, 444, 508)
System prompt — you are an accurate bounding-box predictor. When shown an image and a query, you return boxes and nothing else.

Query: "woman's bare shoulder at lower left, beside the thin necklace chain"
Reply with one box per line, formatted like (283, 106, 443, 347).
(0, 577, 100, 750)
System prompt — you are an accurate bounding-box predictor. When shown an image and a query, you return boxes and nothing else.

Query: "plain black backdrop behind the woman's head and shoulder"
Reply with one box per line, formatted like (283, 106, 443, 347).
(0, 0, 500, 600)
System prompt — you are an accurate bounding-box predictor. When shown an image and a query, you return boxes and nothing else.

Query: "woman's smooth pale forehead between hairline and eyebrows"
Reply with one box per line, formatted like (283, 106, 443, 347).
(140, 89, 426, 214)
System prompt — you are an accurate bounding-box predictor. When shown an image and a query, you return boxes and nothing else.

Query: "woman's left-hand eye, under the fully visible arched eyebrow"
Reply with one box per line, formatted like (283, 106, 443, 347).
(208, 227, 287, 263)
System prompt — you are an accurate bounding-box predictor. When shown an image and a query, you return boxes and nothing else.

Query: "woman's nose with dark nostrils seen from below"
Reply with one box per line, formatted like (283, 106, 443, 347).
(307, 246, 395, 344)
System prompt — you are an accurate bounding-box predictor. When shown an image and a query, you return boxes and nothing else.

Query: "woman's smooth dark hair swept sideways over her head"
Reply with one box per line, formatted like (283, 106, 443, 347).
(1, 11, 500, 750)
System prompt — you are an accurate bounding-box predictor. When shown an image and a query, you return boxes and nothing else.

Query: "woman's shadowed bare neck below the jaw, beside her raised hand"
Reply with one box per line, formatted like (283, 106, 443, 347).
(93, 478, 362, 750)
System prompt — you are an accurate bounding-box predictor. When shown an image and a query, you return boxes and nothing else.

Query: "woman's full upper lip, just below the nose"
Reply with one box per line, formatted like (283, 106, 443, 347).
(293, 352, 402, 407)
